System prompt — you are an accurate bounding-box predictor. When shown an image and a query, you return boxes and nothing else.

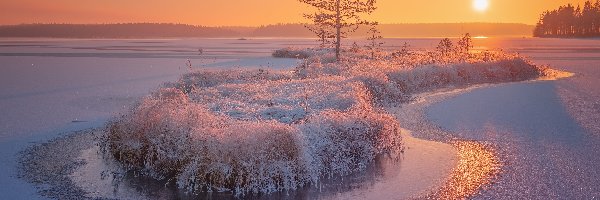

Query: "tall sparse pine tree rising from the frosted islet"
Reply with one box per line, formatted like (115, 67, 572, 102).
(299, 0, 377, 60)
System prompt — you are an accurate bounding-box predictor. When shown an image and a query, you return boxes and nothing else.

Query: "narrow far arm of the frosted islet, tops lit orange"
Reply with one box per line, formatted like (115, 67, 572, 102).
(288, 46, 547, 105)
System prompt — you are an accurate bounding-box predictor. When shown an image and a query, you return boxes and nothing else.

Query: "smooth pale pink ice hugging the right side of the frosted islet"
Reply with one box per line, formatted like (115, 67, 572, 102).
(326, 129, 458, 199)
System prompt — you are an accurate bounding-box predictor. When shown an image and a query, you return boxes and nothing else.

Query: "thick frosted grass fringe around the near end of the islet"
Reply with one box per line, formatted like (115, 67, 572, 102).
(104, 82, 400, 194)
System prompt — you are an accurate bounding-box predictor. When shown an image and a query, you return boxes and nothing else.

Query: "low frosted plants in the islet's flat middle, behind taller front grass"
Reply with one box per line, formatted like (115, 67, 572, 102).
(189, 76, 368, 124)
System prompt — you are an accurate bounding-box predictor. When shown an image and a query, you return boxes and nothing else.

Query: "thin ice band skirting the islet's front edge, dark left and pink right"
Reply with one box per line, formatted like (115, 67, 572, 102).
(21, 130, 458, 199)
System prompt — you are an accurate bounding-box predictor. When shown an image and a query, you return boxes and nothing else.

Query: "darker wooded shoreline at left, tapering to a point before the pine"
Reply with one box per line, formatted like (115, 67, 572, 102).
(0, 23, 241, 38)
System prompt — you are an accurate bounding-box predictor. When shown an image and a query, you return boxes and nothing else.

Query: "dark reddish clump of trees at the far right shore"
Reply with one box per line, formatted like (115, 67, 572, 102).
(533, 0, 600, 37)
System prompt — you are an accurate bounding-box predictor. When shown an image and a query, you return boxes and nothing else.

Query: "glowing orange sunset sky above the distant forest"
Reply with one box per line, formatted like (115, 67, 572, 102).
(0, 0, 585, 26)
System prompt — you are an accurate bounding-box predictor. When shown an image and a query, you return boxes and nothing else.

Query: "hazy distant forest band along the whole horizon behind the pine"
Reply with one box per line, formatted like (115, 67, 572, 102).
(0, 23, 534, 38)
